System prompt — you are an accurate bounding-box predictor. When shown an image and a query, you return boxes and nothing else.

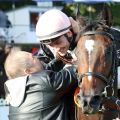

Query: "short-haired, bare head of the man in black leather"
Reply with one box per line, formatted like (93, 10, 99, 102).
(5, 51, 43, 79)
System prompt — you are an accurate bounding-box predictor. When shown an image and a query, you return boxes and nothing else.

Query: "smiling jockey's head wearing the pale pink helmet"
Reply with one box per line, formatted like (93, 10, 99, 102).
(36, 9, 73, 56)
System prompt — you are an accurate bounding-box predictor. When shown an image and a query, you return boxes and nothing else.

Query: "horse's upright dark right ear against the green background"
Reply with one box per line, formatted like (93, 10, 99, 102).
(100, 4, 113, 27)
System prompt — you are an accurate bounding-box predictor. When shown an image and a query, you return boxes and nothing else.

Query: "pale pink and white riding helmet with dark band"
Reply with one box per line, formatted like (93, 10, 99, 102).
(36, 9, 71, 41)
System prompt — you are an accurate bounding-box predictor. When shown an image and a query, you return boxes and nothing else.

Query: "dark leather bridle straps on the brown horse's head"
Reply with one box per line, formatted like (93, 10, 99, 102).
(77, 31, 120, 111)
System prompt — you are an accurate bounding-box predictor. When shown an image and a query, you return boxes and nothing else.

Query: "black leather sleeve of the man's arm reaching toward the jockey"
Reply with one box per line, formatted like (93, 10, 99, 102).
(48, 66, 77, 92)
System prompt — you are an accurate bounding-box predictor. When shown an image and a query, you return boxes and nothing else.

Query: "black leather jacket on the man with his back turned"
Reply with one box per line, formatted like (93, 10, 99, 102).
(4, 67, 77, 120)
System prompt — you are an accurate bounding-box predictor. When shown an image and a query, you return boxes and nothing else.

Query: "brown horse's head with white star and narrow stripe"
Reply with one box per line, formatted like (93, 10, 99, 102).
(74, 19, 113, 114)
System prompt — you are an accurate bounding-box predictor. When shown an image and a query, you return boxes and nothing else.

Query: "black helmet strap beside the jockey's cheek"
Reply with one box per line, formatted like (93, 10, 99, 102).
(64, 34, 76, 50)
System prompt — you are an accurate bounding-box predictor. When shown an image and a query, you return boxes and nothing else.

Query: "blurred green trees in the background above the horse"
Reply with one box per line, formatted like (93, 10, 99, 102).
(54, 2, 120, 26)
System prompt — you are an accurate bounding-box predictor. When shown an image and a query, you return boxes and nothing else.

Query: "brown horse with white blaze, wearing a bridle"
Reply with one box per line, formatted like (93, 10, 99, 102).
(74, 14, 120, 120)
